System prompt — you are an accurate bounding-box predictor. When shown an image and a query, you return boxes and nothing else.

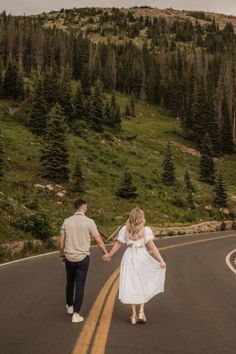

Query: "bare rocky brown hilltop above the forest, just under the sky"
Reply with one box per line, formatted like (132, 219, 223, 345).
(38, 6, 236, 45)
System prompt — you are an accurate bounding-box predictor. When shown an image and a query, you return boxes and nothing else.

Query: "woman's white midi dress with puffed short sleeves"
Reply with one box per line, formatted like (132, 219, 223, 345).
(117, 226, 166, 304)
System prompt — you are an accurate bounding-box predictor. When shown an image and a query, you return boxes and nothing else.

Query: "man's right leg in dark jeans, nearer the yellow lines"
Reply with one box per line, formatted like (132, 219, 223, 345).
(74, 256, 89, 313)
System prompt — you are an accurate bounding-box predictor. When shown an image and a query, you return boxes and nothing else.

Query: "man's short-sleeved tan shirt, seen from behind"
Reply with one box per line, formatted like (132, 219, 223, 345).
(61, 212, 99, 262)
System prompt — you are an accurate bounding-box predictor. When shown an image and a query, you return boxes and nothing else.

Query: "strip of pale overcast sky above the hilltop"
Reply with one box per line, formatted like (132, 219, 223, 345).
(0, 0, 236, 16)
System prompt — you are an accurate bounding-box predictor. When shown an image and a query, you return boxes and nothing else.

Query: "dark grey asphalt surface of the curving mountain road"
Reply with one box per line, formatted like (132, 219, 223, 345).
(0, 231, 236, 354)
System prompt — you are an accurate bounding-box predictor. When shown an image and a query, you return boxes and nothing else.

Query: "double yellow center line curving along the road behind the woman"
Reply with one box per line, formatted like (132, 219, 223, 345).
(72, 234, 236, 354)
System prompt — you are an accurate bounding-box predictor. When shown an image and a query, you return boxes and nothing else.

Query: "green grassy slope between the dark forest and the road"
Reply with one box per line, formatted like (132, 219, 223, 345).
(0, 92, 236, 242)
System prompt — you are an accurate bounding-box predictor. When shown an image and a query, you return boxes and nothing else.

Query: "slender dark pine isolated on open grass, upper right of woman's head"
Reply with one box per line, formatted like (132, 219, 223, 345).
(161, 143, 177, 186)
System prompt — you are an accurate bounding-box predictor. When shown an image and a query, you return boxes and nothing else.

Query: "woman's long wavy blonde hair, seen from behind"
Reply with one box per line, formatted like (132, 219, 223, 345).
(126, 208, 146, 240)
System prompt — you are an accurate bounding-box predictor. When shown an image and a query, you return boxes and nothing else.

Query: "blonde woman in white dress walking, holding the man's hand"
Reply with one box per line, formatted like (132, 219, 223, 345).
(103, 208, 166, 324)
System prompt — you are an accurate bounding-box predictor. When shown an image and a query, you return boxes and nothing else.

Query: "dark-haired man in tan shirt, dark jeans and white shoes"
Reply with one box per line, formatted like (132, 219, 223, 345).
(60, 199, 107, 322)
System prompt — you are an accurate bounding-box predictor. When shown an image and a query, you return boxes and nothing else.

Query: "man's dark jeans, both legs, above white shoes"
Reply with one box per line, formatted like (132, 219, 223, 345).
(65, 256, 89, 313)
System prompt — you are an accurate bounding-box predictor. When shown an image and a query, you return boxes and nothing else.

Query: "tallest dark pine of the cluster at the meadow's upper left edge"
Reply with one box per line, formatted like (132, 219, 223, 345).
(90, 80, 104, 131)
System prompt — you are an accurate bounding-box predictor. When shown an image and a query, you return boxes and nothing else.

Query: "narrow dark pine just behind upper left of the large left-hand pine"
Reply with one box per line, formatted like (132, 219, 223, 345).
(30, 79, 47, 135)
